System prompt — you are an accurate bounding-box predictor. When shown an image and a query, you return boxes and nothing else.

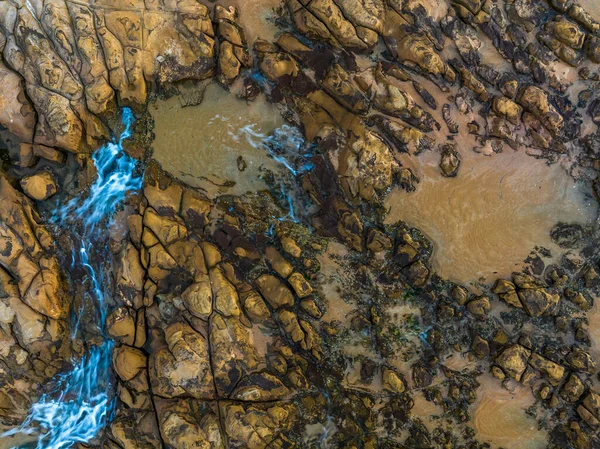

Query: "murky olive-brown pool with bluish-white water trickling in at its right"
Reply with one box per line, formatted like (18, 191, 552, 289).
(150, 84, 283, 195)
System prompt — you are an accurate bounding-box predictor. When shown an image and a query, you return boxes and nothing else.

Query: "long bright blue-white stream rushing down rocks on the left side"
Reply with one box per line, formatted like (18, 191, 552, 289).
(4, 108, 142, 449)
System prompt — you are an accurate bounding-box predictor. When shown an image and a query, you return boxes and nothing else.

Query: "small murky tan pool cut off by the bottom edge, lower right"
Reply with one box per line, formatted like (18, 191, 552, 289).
(472, 374, 547, 449)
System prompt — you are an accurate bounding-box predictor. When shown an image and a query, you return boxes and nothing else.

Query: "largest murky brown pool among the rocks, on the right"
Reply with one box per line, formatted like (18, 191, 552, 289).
(386, 147, 597, 282)
